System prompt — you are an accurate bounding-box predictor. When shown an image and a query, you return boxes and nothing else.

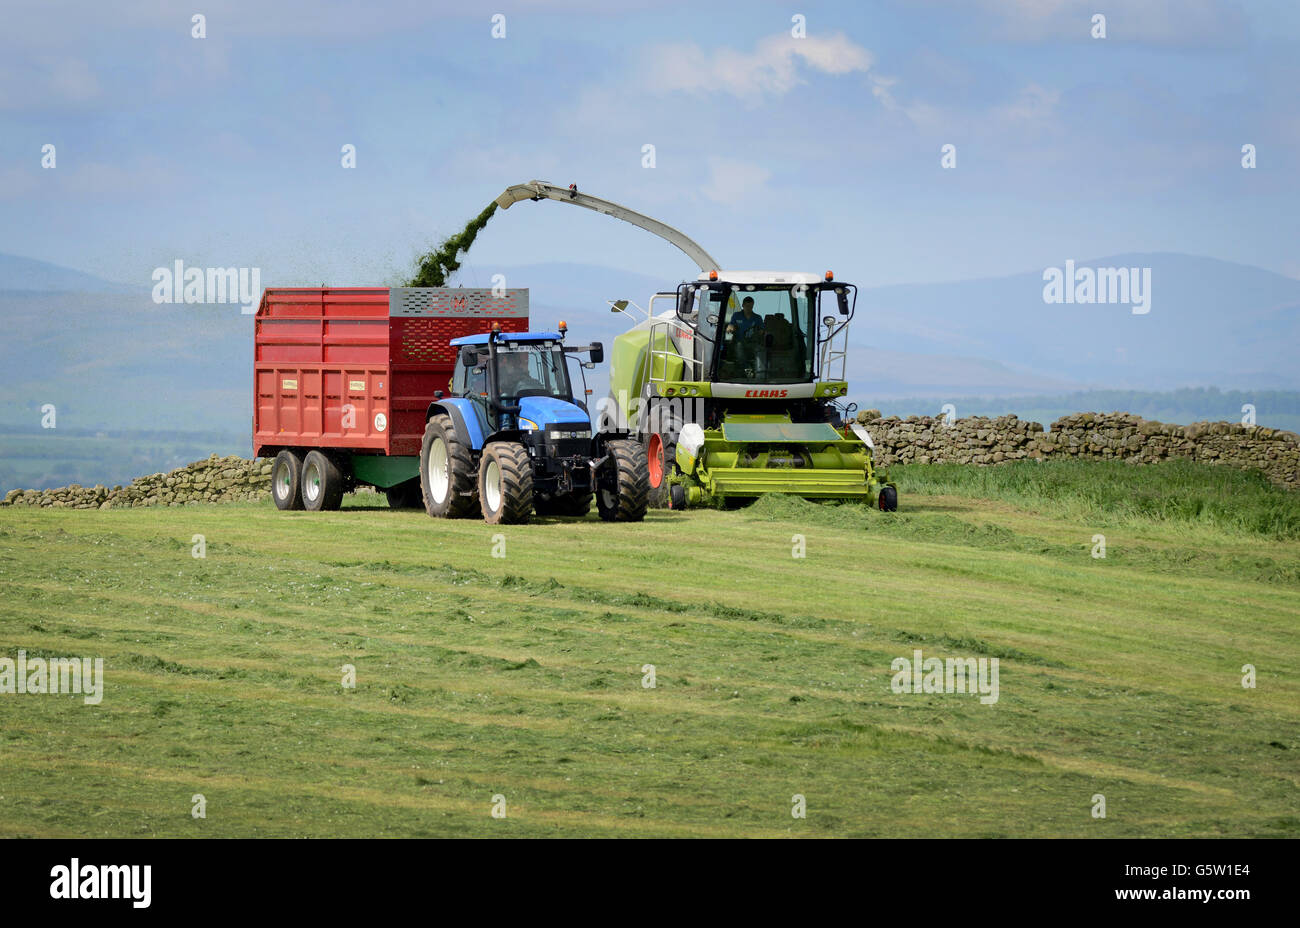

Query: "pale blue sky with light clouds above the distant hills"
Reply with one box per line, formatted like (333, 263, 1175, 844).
(0, 0, 1300, 286)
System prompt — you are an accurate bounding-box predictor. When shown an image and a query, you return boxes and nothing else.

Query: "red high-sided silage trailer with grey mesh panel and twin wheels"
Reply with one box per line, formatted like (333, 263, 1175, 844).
(252, 287, 528, 509)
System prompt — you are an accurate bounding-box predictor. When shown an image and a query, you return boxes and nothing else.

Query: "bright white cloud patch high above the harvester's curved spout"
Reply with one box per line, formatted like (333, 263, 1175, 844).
(642, 32, 874, 101)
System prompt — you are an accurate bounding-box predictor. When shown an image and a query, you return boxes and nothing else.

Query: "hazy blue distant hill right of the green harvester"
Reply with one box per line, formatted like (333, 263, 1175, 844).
(853, 253, 1300, 395)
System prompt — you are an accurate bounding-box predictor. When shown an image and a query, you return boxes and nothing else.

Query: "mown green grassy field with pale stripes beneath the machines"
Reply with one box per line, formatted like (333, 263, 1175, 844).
(0, 463, 1300, 837)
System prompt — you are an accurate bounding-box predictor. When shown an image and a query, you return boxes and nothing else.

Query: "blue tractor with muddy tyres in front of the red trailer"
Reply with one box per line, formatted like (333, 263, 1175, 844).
(420, 322, 650, 525)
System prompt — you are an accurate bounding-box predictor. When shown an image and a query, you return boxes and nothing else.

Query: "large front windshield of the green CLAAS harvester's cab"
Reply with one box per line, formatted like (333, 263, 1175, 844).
(718, 285, 818, 383)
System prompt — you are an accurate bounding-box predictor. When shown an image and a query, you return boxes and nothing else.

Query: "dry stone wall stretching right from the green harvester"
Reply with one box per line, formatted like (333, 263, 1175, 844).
(858, 409, 1300, 490)
